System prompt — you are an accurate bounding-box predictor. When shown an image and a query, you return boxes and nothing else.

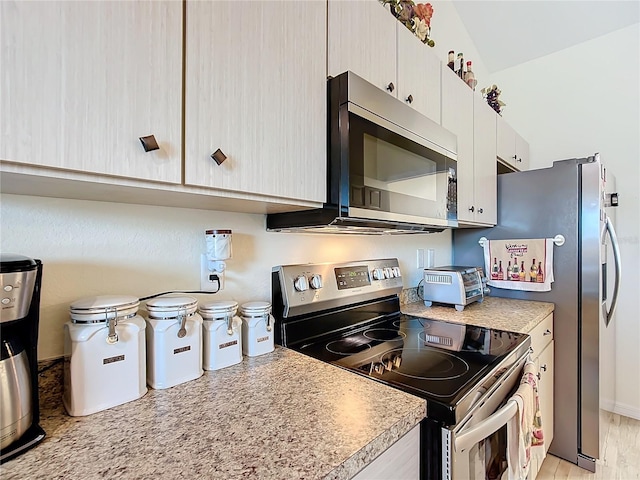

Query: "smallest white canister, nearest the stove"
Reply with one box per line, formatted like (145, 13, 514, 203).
(240, 302, 274, 357)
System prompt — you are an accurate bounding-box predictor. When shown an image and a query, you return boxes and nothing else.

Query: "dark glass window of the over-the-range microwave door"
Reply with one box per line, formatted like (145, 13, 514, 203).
(349, 112, 457, 220)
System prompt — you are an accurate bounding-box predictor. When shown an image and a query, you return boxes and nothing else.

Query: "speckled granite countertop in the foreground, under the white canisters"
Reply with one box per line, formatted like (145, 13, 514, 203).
(5, 347, 425, 480)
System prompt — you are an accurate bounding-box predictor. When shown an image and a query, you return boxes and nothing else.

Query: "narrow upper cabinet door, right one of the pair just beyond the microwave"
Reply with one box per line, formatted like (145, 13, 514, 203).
(473, 95, 498, 225)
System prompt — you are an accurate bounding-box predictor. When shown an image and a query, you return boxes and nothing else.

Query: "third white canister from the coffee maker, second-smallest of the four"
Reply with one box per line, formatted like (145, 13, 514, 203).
(198, 300, 242, 370)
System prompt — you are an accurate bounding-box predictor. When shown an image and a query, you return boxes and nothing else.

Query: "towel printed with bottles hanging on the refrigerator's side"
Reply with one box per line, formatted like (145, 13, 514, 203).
(483, 238, 554, 292)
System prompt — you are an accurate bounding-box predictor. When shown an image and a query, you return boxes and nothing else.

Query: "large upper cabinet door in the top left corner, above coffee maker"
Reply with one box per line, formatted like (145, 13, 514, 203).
(0, 1, 182, 183)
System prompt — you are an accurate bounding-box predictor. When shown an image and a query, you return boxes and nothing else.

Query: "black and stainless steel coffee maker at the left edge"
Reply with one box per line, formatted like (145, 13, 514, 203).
(0, 254, 45, 463)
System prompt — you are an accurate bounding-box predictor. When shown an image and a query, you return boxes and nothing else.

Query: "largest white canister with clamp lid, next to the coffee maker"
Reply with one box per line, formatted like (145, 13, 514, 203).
(63, 295, 147, 416)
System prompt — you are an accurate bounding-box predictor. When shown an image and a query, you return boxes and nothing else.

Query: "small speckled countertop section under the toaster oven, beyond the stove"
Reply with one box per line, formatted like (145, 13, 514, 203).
(401, 297, 554, 333)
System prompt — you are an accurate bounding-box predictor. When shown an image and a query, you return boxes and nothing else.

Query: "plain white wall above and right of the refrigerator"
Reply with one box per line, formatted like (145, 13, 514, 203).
(493, 24, 640, 418)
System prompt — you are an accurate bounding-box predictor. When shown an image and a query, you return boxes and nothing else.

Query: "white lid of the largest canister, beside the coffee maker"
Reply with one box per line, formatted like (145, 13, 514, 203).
(69, 295, 140, 323)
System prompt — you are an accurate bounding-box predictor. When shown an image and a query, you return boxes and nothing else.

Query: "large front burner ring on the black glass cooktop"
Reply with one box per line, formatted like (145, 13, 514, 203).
(380, 347, 469, 380)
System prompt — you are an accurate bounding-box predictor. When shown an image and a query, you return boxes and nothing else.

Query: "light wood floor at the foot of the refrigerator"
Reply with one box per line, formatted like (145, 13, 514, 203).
(536, 410, 640, 480)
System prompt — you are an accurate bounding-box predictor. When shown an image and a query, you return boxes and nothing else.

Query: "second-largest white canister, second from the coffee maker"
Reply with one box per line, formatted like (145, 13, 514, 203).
(145, 296, 204, 389)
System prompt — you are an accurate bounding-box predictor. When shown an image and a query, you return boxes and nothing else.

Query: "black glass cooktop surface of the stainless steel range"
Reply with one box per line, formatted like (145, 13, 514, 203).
(297, 314, 528, 423)
